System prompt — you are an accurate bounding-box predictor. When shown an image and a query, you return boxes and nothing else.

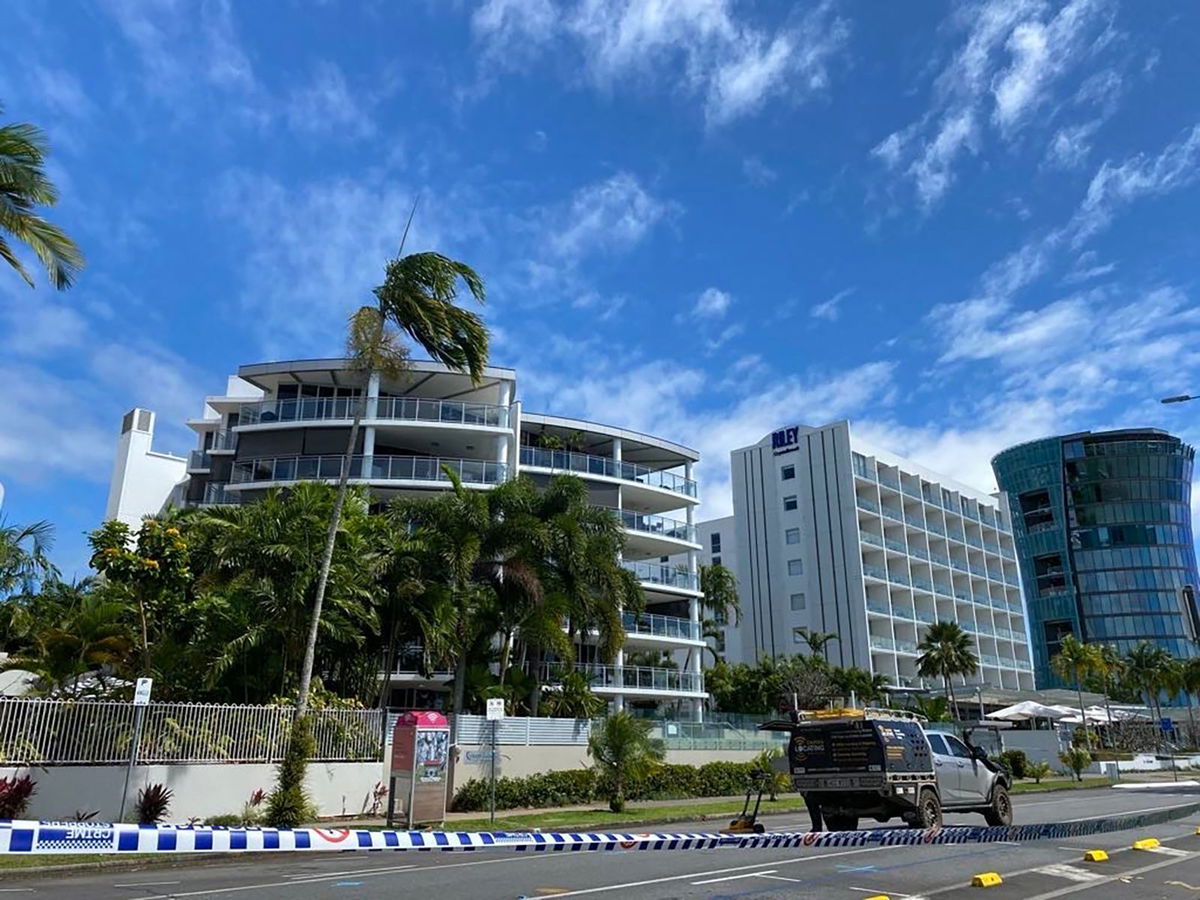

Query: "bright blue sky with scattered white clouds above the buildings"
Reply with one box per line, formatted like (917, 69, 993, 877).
(0, 0, 1200, 572)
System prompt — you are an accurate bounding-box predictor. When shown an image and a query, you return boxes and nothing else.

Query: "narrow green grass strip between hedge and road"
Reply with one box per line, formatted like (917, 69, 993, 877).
(448, 796, 804, 832)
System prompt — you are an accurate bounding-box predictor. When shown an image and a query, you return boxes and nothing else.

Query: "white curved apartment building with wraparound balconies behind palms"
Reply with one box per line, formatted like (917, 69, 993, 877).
(106, 359, 707, 718)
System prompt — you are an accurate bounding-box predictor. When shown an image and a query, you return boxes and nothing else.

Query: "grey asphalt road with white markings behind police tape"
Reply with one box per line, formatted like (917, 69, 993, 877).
(7, 788, 1200, 900)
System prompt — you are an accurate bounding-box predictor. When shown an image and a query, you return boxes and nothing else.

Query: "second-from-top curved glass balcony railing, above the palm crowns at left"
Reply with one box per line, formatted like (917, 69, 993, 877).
(229, 456, 509, 485)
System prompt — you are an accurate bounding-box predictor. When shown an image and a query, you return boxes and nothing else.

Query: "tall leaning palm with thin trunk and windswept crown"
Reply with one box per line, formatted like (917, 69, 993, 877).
(296, 241, 488, 714)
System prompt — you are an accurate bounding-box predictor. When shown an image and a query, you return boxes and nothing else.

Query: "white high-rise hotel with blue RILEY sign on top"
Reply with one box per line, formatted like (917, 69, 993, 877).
(715, 421, 1033, 690)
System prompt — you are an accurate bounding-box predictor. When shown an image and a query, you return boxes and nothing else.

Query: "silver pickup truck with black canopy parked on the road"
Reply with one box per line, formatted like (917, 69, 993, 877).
(761, 709, 1013, 832)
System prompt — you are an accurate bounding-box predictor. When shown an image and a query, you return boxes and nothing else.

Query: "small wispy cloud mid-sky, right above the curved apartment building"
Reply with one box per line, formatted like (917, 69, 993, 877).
(547, 172, 672, 260)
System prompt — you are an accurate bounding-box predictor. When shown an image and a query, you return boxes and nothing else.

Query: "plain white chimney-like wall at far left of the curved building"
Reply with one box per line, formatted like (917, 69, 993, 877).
(104, 409, 187, 528)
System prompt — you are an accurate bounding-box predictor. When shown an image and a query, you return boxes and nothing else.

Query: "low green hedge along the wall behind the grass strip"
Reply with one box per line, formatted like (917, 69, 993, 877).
(451, 762, 768, 812)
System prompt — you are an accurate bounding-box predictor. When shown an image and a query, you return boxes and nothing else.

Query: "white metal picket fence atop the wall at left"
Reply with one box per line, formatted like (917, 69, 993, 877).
(0, 698, 383, 766)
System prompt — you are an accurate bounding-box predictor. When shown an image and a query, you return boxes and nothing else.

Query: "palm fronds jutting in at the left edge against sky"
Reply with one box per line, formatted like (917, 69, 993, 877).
(0, 107, 84, 290)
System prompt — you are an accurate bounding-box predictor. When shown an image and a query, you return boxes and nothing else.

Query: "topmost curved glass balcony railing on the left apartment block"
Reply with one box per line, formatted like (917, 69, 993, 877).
(238, 397, 509, 428)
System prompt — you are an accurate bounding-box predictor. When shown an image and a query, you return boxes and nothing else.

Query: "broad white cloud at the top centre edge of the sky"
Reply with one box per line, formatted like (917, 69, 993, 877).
(472, 0, 848, 126)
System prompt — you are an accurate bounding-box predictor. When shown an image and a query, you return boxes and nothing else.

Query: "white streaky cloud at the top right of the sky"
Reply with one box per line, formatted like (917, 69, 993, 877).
(871, 0, 1111, 212)
